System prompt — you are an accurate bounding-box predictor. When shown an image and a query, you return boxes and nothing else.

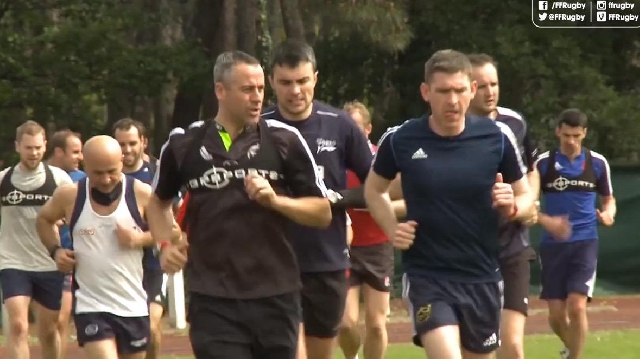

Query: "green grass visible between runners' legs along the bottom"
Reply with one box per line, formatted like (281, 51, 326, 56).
(163, 330, 640, 359)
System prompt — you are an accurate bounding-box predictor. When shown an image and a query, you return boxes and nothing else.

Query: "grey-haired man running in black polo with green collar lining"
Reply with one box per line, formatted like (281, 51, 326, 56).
(148, 51, 332, 359)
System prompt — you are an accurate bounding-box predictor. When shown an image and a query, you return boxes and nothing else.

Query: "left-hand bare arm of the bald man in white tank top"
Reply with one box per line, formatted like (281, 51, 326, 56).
(36, 184, 77, 254)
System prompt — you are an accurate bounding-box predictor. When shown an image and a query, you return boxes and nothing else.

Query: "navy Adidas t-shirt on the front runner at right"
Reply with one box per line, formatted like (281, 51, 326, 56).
(373, 116, 526, 282)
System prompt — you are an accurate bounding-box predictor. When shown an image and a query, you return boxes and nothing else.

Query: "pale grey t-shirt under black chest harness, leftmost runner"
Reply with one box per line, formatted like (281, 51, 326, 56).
(0, 163, 73, 272)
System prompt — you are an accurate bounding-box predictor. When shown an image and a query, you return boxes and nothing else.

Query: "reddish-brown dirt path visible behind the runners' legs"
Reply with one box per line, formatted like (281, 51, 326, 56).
(5, 296, 640, 359)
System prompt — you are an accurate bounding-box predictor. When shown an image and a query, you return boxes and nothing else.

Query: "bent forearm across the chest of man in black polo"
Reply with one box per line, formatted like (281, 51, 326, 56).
(272, 196, 332, 228)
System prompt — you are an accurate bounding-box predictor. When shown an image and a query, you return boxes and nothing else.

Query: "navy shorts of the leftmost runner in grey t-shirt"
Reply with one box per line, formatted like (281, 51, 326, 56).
(0, 269, 64, 310)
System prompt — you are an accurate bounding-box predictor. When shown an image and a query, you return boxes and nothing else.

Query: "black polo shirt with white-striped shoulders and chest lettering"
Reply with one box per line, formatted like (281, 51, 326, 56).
(154, 120, 326, 299)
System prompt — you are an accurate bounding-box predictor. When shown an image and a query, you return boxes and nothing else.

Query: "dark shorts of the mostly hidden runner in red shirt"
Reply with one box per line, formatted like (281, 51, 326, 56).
(349, 241, 394, 292)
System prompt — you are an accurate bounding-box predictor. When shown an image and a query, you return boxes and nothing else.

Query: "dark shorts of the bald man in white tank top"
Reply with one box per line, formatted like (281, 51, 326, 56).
(73, 312, 149, 355)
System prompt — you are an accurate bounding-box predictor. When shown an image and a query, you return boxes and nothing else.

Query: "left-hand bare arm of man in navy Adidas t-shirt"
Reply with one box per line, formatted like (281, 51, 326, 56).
(364, 170, 398, 238)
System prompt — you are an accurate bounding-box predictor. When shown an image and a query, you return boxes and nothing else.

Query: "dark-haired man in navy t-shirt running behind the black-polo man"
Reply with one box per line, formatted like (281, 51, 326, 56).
(263, 40, 372, 359)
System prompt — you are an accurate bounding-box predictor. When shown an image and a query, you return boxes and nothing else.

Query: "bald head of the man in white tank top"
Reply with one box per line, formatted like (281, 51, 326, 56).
(82, 135, 122, 192)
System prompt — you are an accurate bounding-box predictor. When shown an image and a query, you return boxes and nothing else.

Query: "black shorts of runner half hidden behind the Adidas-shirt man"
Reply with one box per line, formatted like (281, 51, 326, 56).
(499, 247, 536, 316)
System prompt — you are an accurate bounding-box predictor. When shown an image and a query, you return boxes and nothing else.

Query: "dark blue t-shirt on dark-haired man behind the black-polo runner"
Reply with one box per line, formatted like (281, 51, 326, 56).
(262, 101, 372, 273)
